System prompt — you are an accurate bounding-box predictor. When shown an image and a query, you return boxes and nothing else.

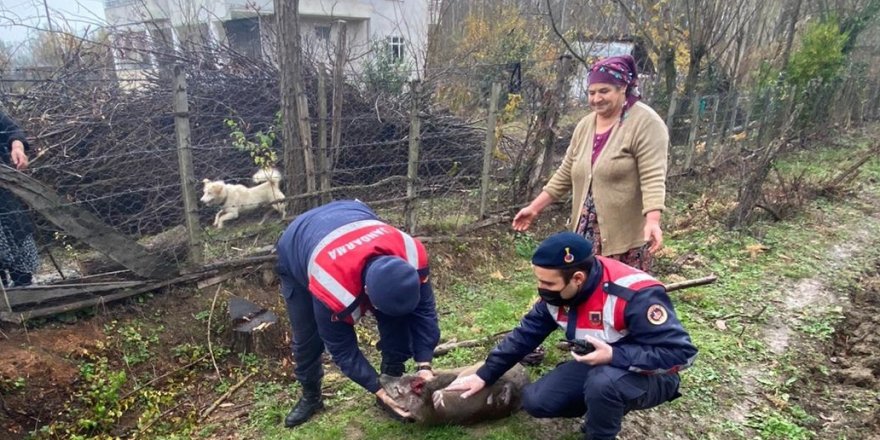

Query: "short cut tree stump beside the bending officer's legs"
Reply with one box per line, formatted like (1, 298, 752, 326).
(229, 296, 281, 357)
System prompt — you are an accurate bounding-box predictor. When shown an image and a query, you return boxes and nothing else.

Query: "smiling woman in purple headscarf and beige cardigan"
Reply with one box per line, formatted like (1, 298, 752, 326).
(513, 55, 669, 271)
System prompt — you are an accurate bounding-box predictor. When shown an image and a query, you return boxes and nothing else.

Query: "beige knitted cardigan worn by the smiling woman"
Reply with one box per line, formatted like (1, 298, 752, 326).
(544, 102, 669, 255)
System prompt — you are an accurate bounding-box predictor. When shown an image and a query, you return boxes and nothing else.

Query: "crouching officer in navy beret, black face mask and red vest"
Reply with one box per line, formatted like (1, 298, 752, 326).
(446, 232, 697, 440)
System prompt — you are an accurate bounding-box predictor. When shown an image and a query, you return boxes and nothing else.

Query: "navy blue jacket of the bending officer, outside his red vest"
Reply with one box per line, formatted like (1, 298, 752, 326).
(277, 200, 440, 393)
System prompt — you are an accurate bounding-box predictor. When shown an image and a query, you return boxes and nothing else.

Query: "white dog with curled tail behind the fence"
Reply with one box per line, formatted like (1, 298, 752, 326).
(201, 168, 286, 229)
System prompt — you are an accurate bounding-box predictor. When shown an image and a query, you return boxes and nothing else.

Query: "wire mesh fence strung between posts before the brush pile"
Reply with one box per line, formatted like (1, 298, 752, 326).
(0, 34, 880, 294)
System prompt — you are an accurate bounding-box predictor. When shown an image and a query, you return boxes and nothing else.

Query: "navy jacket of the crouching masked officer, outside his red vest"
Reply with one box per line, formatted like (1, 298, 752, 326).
(476, 261, 697, 385)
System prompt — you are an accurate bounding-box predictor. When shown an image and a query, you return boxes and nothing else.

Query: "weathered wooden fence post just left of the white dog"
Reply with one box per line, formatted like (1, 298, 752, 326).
(173, 65, 204, 265)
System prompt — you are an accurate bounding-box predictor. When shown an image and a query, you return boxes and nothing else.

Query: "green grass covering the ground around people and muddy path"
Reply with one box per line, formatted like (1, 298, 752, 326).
(31, 129, 880, 440)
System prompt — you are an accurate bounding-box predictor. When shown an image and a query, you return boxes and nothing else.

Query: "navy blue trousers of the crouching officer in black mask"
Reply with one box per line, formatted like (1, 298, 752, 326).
(523, 361, 680, 440)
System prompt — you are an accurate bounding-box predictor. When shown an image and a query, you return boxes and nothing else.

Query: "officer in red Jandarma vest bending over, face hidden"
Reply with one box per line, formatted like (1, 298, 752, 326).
(275, 201, 440, 428)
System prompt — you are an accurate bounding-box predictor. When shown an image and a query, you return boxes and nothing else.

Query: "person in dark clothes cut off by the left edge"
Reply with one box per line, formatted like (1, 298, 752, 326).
(0, 110, 40, 287)
